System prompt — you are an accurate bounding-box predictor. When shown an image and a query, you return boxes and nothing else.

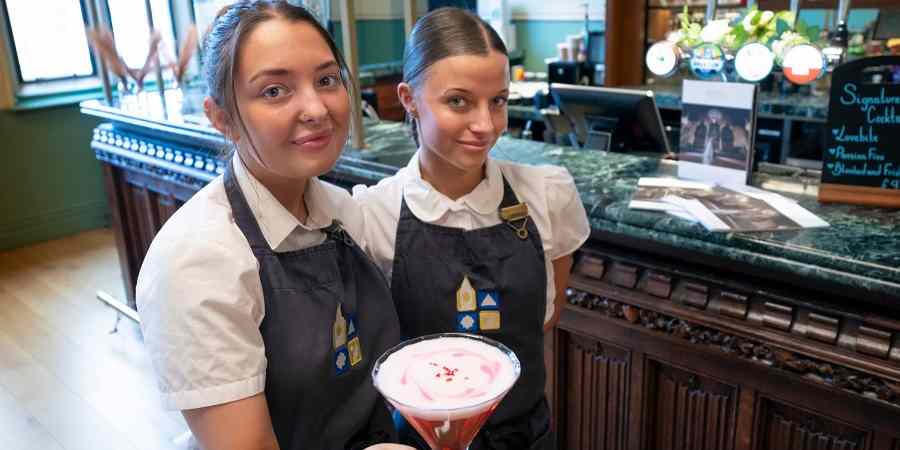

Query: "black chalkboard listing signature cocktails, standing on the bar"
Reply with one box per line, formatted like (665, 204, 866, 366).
(819, 56, 900, 207)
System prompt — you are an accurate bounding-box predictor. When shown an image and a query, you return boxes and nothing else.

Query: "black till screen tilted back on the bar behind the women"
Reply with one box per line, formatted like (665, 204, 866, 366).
(550, 83, 671, 154)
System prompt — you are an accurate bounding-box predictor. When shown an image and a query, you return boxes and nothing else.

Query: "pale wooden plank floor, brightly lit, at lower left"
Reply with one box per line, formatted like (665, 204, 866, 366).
(0, 229, 187, 450)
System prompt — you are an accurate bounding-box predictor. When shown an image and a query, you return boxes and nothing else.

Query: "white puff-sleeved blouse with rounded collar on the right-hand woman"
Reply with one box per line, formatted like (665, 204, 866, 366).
(353, 153, 591, 323)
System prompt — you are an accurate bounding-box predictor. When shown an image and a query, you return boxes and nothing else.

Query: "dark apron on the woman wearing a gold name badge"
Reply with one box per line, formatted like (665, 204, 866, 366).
(391, 174, 555, 450)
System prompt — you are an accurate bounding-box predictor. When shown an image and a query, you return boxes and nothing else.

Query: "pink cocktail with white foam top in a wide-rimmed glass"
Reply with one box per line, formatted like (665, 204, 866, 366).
(372, 333, 522, 450)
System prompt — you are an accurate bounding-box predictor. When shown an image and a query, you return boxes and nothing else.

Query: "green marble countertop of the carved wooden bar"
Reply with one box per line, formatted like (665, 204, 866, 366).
(81, 95, 900, 299)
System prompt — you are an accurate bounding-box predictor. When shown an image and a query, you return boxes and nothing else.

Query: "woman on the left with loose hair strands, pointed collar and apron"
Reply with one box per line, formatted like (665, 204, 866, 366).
(137, 0, 401, 450)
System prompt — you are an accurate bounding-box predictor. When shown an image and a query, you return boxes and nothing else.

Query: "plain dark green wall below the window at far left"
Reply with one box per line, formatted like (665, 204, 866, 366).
(0, 105, 109, 250)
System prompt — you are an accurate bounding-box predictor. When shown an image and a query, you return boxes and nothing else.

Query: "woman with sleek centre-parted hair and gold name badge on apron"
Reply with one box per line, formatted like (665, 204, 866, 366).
(354, 8, 590, 449)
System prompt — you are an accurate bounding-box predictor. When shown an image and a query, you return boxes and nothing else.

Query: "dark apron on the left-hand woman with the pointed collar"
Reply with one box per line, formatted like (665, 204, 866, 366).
(225, 164, 400, 450)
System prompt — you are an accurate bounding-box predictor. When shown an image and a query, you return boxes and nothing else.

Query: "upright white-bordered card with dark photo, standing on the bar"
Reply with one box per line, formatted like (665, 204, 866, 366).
(678, 80, 757, 184)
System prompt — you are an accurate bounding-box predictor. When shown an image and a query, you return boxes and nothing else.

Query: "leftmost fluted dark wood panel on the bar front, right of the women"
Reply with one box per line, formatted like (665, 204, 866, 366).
(565, 334, 629, 450)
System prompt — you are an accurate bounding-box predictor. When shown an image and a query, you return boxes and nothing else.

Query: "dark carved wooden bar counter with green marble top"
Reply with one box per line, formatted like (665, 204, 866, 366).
(82, 94, 900, 450)
